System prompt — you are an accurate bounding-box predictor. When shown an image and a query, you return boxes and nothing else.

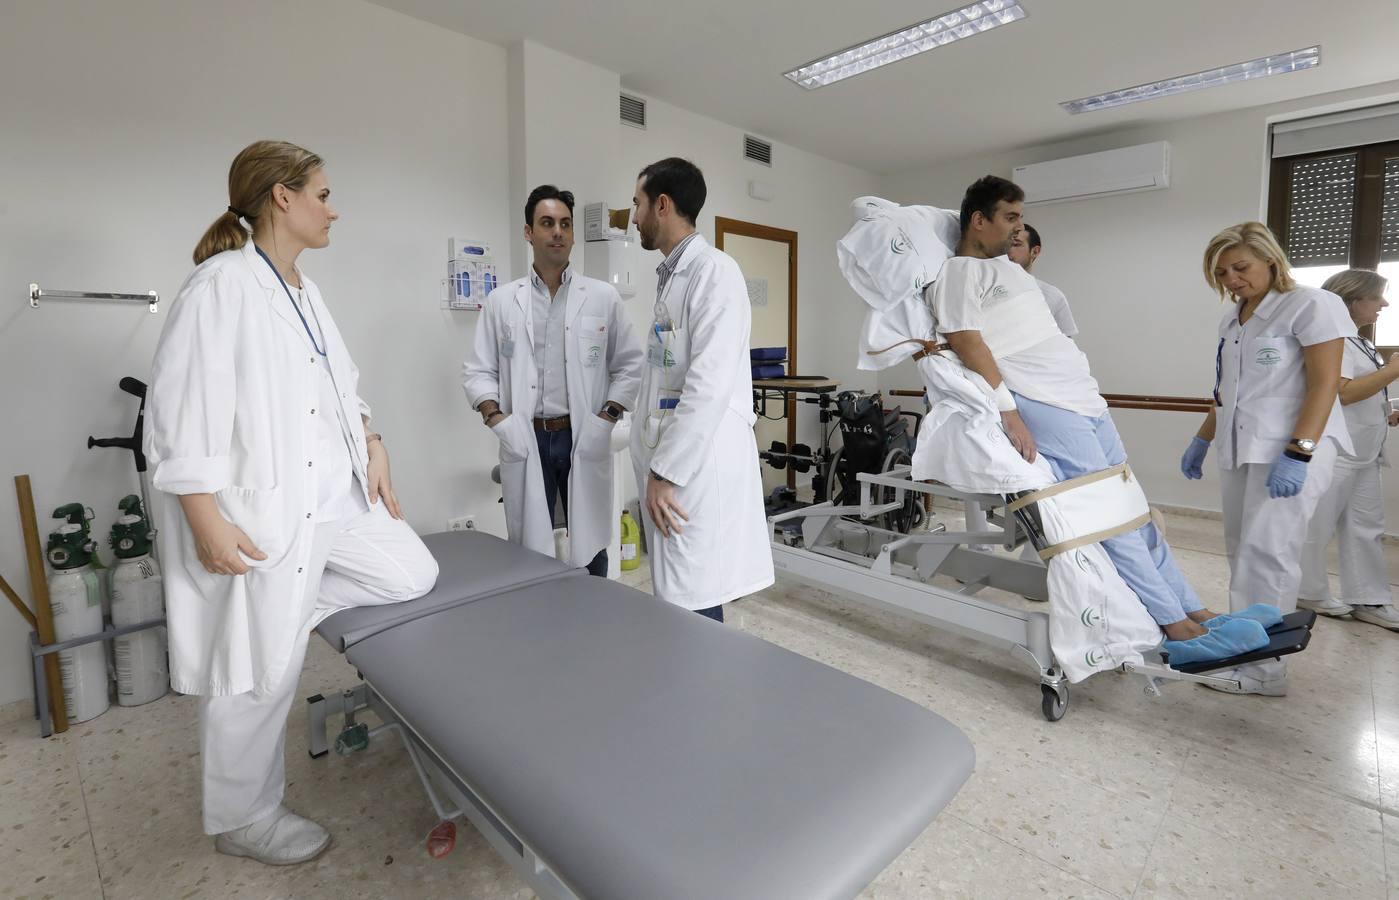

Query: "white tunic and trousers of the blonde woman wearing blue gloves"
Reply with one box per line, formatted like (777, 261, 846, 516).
(1214, 287, 1356, 613)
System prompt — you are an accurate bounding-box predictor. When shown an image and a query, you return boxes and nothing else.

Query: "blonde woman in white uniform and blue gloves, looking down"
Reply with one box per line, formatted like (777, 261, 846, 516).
(1181, 223, 1356, 697)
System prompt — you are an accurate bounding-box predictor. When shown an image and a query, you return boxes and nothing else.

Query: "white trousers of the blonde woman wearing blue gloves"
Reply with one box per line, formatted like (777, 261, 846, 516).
(1220, 440, 1336, 616)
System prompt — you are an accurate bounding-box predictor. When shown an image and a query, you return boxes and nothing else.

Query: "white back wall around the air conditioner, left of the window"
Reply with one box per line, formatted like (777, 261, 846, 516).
(881, 83, 1399, 522)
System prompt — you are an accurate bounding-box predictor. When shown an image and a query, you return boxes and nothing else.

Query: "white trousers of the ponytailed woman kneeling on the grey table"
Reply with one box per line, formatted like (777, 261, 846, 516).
(199, 500, 438, 834)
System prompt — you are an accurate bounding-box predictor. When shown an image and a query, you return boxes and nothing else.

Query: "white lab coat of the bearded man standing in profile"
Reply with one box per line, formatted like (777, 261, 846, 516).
(631, 237, 774, 609)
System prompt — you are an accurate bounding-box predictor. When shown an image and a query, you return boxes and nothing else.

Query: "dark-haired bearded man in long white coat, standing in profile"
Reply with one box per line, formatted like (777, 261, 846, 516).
(631, 158, 774, 621)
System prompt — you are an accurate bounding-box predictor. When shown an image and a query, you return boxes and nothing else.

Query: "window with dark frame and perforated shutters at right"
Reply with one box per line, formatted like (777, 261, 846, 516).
(1267, 141, 1399, 350)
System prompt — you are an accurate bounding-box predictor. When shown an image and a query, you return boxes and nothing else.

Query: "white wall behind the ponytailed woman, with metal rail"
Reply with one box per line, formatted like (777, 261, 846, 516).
(0, 0, 509, 704)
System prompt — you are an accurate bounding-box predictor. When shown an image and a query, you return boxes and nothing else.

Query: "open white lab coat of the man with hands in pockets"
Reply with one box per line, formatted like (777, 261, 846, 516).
(462, 274, 644, 567)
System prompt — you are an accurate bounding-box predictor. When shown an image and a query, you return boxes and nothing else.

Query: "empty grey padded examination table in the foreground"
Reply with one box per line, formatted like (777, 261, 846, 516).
(308, 532, 974, 900)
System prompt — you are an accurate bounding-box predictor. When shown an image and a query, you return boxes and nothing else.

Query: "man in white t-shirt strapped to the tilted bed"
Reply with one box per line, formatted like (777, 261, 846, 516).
(925, 175, 1236, 658)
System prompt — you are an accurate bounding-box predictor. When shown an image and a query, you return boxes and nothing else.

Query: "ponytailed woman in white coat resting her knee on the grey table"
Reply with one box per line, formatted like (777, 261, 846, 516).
(145, 141, 438, 865)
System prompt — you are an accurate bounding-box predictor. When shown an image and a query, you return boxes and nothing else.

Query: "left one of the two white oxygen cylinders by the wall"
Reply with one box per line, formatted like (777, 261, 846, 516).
(46, 502, 112, 722)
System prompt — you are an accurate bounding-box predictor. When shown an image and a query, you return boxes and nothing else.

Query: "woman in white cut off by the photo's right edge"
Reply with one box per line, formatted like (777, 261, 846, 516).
(1297, 269, 1399, 631)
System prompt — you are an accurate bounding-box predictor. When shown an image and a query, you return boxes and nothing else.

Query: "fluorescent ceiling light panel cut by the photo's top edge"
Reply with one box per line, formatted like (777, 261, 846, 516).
(782, 0, 1025, 91)
